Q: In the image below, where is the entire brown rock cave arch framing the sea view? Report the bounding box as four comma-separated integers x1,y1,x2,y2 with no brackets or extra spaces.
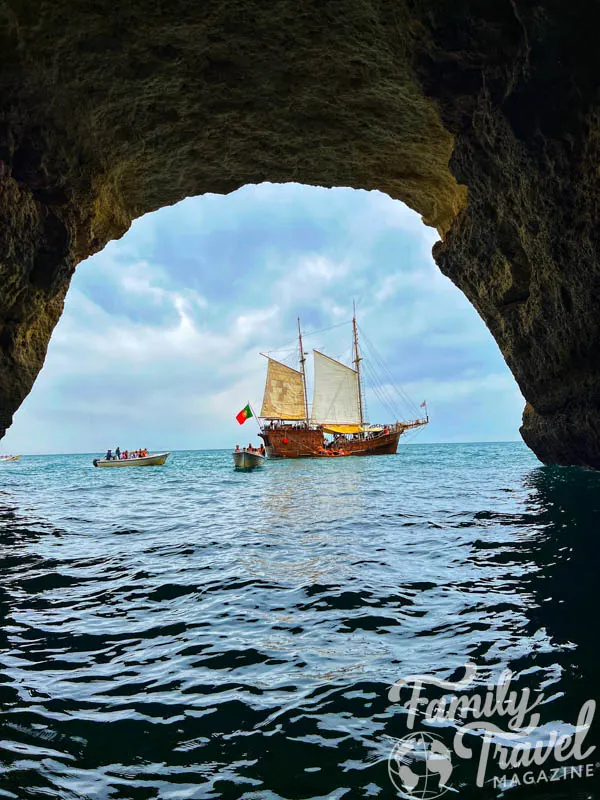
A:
0,0,600,466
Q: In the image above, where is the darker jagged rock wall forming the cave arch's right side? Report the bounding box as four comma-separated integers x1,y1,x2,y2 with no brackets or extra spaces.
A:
416,0,600,468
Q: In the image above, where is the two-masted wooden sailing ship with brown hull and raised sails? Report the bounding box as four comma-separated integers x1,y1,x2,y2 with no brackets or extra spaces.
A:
258,311,429,458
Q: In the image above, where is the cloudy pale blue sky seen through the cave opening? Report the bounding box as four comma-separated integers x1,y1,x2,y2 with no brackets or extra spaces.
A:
0,183,524,454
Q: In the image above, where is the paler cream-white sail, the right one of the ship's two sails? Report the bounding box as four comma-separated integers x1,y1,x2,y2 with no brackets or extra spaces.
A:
312,350,361,425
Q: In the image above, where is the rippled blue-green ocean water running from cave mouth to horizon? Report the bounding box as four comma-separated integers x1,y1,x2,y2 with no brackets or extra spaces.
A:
0,444,600,800
